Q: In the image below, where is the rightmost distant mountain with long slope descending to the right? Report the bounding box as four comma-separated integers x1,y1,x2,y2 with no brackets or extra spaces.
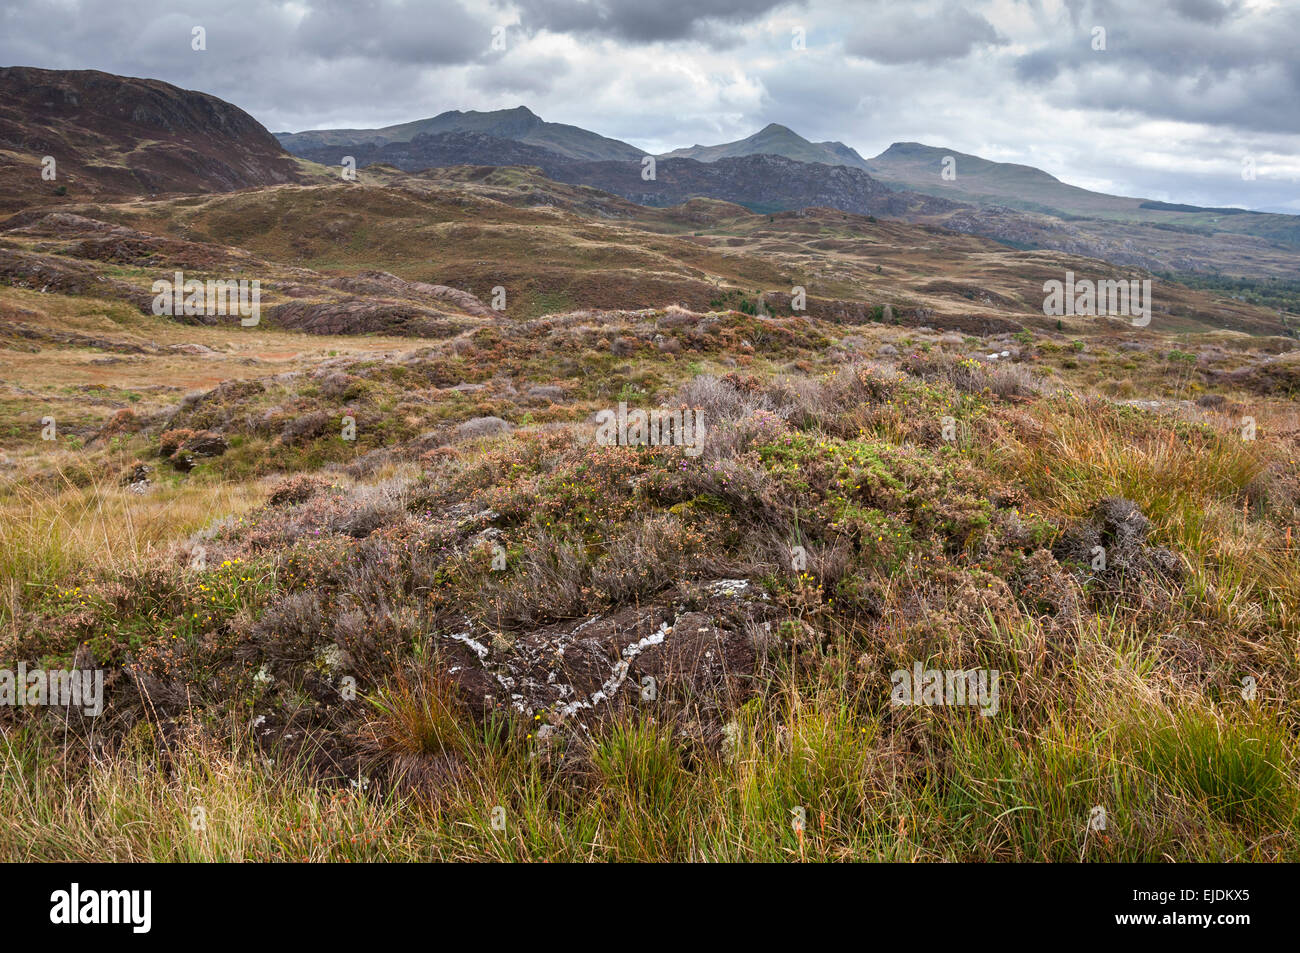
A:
866,142,1300,246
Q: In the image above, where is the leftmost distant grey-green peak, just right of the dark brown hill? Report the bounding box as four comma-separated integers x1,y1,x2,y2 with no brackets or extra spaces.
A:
276,105,645,165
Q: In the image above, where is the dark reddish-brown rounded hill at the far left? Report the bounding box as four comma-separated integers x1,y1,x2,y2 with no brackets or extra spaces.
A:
0,66,300,209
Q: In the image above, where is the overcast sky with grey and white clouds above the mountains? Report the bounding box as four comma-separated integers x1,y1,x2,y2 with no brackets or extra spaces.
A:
0,0,1300,212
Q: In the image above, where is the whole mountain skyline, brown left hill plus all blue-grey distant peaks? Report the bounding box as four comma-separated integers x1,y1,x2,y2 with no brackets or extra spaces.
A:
0,68,1300,281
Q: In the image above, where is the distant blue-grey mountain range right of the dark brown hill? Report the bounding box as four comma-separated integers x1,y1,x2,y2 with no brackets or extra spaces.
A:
278,107,1300,263
